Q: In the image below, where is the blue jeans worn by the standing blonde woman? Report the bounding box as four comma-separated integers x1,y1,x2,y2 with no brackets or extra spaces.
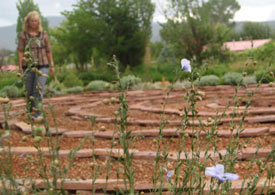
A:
25,67,49,116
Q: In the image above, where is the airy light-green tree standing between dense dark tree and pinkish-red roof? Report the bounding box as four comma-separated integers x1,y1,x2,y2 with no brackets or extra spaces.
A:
161,0,240,63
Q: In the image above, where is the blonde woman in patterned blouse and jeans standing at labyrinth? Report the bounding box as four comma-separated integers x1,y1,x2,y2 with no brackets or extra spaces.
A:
17,11,54,119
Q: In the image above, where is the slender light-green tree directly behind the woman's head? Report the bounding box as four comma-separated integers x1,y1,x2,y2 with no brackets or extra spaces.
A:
16,0,49,42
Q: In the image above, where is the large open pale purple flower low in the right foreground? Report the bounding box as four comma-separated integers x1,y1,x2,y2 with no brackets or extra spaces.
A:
205,164,239,182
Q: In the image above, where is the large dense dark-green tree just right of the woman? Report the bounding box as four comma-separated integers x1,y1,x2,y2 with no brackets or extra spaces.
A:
52,0,154,67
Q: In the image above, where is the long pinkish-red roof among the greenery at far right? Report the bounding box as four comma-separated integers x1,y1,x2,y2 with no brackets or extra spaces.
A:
224,39,271,51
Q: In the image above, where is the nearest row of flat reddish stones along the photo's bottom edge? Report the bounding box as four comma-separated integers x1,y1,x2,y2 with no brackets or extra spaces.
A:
6,178,275,195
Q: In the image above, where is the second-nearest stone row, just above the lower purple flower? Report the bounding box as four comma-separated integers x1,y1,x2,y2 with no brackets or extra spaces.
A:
0,147,273,161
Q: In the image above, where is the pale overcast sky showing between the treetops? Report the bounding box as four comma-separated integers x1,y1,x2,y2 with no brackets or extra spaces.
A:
0,0,275,26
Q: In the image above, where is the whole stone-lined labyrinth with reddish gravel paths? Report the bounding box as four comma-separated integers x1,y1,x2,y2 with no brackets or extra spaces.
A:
0,85,275,194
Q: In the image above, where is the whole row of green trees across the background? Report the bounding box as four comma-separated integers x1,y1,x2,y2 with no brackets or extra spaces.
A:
17,0,274,69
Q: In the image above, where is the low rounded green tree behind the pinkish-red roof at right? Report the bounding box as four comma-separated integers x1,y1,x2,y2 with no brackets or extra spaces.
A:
240,22,273,39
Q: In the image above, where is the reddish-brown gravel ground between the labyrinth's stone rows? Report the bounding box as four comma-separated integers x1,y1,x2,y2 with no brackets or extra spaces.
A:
0,85,275,186
